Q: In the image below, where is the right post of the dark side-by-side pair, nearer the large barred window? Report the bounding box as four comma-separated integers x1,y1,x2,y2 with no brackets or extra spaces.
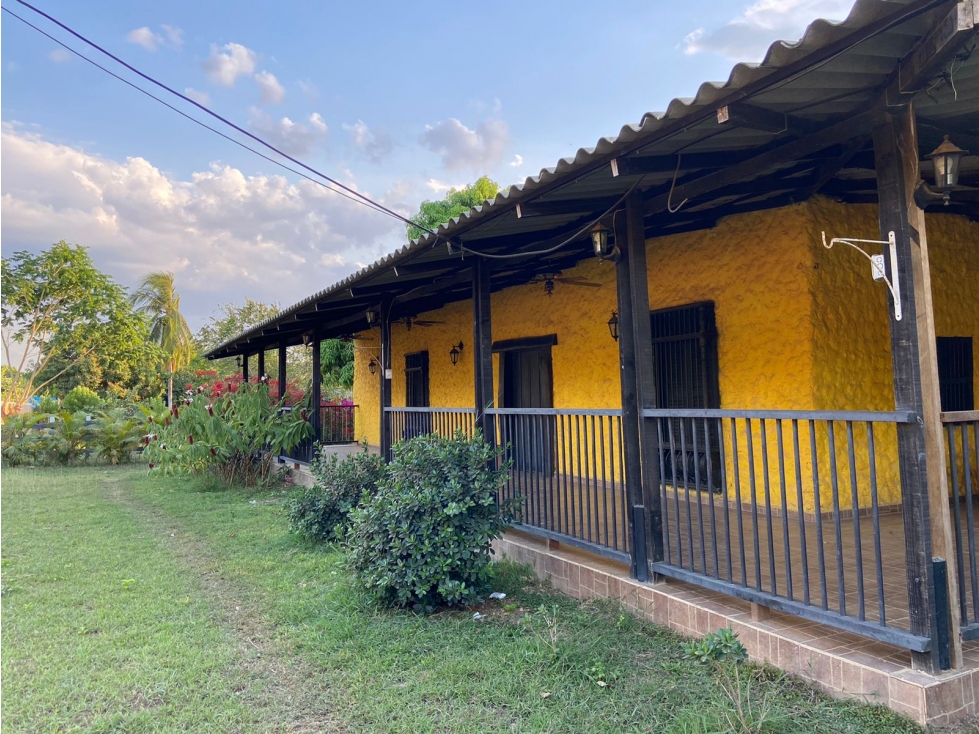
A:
620,191,663,576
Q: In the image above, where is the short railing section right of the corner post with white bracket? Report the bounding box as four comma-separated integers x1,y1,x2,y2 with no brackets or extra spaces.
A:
942,410,979,640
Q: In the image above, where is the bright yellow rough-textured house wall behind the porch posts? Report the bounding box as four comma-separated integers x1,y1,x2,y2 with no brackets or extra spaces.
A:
354,197,979,511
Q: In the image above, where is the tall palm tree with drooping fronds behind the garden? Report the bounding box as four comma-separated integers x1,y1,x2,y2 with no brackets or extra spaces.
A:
129,271,194,406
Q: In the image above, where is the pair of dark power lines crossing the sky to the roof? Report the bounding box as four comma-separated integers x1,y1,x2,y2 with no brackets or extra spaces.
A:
3,0,447,241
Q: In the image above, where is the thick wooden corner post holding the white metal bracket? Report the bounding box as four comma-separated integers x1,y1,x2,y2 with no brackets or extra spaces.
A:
874,104,962,673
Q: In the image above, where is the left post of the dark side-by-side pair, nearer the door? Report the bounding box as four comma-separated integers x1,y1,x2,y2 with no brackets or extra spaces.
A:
614,216,649,581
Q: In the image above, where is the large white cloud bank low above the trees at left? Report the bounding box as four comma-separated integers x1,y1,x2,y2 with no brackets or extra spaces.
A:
0,124,403,323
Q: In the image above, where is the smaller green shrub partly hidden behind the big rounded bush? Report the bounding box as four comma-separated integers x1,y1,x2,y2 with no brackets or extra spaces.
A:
289,452,386,543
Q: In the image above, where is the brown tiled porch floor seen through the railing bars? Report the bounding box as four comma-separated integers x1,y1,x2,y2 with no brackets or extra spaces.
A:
508,472,979,630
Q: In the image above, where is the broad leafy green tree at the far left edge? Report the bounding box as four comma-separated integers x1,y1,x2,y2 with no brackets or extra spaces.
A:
0,240,145,419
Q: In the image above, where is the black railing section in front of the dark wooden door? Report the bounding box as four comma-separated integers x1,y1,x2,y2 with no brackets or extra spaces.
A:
486,408,631,562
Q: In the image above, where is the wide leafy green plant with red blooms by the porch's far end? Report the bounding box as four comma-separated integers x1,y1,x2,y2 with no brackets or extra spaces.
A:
143,381,312,485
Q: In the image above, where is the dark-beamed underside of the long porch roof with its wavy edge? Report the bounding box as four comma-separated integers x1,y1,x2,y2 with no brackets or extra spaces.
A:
206,0,979,359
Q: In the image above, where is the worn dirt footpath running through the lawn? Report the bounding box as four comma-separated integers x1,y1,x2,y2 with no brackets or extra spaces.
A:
106,478,346,734
